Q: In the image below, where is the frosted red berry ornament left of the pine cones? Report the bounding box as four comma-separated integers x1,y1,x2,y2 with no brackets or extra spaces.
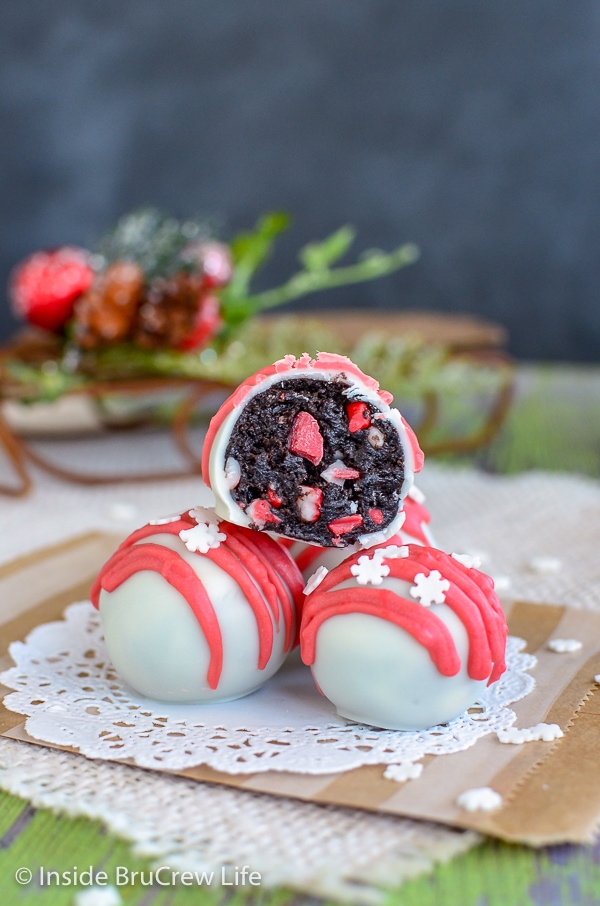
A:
9,246,94,331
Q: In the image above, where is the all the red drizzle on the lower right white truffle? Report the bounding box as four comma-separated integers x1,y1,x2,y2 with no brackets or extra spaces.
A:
300,544,507,685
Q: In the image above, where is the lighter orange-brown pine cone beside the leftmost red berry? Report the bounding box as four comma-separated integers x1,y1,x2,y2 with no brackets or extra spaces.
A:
74,261,144,349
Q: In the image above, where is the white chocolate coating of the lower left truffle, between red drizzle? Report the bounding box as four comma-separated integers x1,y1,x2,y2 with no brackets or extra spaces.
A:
99,534,293,702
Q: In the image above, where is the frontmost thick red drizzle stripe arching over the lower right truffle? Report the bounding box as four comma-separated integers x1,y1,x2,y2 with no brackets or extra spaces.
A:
302,588,460,676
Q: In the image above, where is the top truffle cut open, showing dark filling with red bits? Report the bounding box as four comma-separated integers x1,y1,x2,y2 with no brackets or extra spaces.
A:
202,353,423,548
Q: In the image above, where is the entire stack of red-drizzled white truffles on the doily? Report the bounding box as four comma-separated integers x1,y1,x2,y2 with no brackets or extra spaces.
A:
93,353,506,729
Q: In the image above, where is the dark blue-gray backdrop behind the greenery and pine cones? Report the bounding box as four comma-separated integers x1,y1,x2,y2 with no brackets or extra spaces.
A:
0,0,600,361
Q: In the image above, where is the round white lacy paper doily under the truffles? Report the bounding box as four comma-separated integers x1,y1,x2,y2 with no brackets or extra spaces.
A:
0,602,535,774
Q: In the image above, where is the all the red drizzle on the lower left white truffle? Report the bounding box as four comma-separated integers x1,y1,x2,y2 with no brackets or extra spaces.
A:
90,513,304,689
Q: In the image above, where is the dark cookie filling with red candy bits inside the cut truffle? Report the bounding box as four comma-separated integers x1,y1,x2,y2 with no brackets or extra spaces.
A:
225,378,404,547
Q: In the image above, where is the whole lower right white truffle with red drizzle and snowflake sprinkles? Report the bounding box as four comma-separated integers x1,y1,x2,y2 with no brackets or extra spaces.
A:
300,544,507,730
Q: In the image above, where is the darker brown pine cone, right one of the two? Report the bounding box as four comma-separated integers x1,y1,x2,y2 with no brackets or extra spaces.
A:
133,271,201,349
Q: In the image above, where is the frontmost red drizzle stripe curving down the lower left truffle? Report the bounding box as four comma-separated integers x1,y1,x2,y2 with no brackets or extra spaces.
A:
102,543,223,689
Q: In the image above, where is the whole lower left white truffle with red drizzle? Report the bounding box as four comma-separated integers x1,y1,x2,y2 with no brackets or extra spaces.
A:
92,507,303,702
